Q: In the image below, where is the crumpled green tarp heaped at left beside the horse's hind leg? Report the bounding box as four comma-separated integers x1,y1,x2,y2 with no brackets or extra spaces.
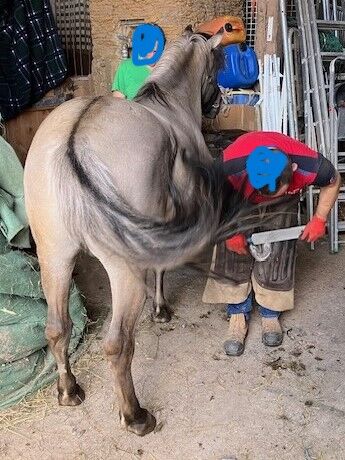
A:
0,136,87,410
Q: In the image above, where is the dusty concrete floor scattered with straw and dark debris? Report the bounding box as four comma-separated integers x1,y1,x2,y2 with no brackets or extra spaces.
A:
0,245,345,460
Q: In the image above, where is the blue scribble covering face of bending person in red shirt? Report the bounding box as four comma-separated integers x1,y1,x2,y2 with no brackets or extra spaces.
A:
246,147,288,193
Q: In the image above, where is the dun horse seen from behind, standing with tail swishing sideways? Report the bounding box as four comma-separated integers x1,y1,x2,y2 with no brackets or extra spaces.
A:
24,27,242,436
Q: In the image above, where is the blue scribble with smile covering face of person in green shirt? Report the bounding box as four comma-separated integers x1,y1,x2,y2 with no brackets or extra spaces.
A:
132,24,165,65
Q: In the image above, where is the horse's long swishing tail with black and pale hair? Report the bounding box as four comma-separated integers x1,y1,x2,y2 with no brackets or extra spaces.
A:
55,97,245,268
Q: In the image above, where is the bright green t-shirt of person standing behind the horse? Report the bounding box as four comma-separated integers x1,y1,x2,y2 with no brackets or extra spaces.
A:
111,59,151,100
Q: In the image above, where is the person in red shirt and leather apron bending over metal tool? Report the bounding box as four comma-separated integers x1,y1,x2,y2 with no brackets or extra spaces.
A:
203,132,340,356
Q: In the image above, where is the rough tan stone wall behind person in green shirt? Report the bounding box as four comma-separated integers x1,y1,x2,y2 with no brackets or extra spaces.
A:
90,0,243,94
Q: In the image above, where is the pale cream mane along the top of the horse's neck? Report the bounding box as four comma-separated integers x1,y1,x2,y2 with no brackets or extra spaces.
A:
134,34,224,105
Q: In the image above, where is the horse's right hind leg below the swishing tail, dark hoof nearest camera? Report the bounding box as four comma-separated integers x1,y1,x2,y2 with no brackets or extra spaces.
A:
97,253,156,436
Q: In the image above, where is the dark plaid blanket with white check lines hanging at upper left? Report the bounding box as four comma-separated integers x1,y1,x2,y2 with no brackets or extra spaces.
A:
0,0,67,120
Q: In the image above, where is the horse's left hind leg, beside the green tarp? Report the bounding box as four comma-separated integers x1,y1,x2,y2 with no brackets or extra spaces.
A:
36,239,85,406
